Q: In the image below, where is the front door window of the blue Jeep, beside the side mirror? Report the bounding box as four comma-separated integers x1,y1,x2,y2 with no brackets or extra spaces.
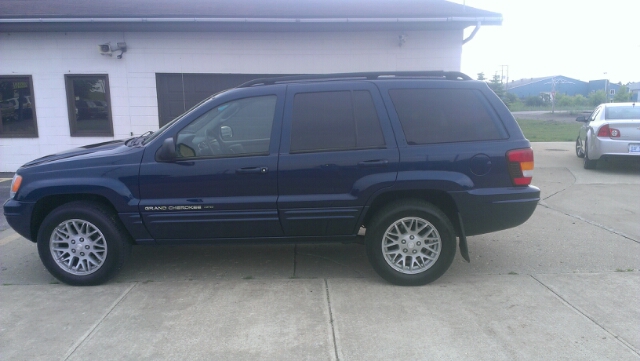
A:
176,95,278,158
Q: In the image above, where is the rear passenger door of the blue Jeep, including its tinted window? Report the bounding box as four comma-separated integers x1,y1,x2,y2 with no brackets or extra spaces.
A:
278,82,399,236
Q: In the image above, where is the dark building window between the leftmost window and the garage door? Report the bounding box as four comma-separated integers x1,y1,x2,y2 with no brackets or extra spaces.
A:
65,75,113,137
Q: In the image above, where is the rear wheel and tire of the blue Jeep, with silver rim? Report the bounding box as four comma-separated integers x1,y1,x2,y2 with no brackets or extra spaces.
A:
365,200,456,286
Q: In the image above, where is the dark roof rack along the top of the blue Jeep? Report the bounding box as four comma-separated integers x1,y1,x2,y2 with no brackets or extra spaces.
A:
238,70,472,88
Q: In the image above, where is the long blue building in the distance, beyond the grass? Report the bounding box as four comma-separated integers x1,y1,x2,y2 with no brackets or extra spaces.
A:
505,75,620,101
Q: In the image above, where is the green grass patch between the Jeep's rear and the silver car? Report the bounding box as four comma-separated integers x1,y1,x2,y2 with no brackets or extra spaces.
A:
518,119,582,142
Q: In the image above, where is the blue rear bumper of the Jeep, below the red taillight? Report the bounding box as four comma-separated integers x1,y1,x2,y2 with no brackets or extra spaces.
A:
451,186,540,236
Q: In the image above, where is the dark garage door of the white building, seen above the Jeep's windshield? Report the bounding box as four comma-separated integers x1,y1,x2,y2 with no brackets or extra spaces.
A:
156,73,280,126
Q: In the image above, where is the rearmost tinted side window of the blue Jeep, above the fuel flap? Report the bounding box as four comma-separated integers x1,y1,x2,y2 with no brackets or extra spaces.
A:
389,89,506,145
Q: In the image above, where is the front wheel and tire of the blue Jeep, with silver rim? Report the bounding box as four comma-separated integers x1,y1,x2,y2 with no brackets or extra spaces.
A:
38,201,131,286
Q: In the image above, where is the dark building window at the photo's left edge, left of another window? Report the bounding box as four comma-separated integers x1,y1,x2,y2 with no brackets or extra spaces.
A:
0,76,38,138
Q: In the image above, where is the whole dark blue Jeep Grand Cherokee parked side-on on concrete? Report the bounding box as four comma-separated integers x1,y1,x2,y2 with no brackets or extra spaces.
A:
4,72,540,285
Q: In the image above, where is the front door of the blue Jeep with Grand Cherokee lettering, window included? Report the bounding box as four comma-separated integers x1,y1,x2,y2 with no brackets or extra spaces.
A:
140,87,284,242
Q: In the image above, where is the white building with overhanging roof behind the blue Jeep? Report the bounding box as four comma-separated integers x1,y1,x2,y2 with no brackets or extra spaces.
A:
0,0,502,172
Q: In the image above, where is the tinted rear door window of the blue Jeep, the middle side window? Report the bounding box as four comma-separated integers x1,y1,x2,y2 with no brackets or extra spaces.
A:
291,91,384,153
